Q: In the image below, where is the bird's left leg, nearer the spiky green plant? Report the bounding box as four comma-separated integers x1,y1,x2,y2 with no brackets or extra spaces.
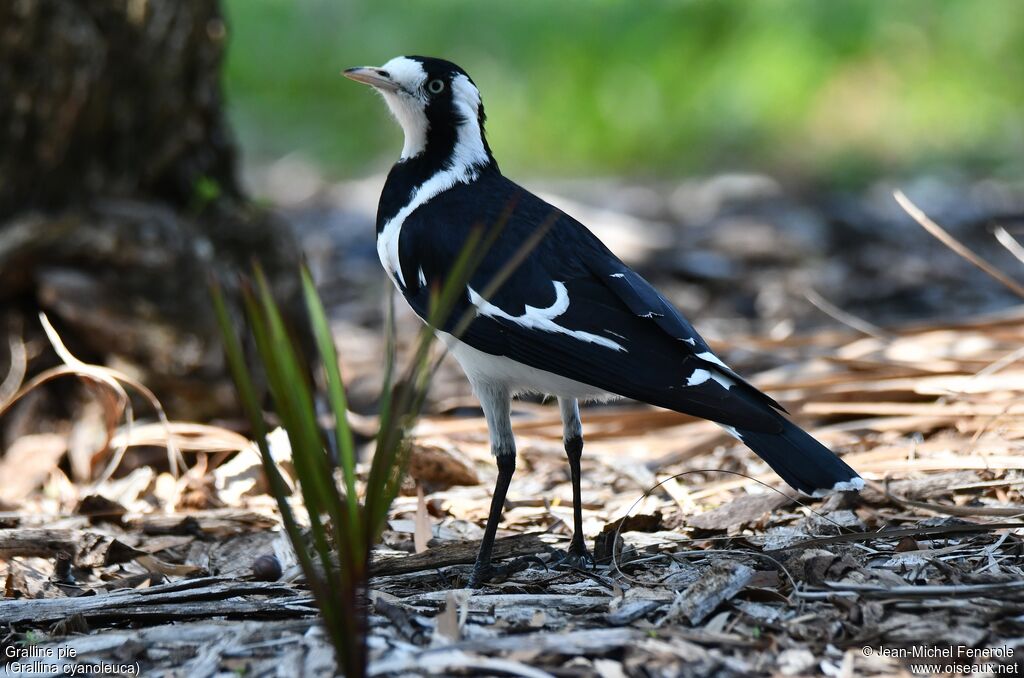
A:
469,386,544,588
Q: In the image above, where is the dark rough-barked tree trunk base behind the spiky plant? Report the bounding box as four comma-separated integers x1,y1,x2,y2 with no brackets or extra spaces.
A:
0,0,298,416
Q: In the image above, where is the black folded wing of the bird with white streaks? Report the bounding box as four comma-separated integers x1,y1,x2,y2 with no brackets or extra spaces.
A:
399,173,782,432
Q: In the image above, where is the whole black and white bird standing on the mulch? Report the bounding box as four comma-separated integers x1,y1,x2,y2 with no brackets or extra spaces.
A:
344,56,863,586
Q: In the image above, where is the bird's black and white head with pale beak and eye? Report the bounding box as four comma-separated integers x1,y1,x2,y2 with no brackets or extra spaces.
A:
343,56,494,167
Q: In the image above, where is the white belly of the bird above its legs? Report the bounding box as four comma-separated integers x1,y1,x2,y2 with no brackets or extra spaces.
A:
437,332,615,400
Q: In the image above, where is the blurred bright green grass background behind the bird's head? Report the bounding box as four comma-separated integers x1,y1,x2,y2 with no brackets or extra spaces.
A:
226,0,1024,183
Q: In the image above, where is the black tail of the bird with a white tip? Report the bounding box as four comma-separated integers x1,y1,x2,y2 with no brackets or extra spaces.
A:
736,417,864,497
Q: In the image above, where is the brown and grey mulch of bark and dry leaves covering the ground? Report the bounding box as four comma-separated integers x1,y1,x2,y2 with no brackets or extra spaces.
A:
0,308,1024,676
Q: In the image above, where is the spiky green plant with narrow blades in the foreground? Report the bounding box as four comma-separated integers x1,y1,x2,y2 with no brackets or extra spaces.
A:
212,242,480,678
